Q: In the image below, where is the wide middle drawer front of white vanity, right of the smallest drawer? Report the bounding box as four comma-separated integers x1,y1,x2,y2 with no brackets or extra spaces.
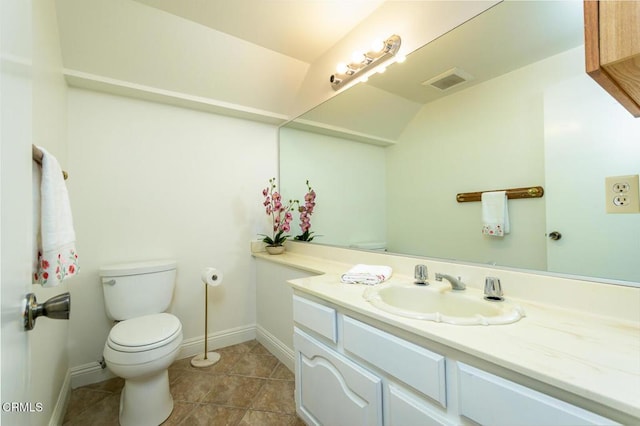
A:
343,316,447,407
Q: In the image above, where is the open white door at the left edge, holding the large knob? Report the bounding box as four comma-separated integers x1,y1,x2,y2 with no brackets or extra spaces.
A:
0,0,37,426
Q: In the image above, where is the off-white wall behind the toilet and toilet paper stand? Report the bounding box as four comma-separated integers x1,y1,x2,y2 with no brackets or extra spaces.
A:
69,89,277,366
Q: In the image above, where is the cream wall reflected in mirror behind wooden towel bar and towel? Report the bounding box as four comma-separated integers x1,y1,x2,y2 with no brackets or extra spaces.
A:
387,49,583,270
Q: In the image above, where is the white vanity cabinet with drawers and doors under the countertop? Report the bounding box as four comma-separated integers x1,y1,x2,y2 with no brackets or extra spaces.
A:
293,292,618,426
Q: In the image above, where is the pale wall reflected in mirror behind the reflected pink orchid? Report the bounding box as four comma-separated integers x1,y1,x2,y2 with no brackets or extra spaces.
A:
280,128,386,246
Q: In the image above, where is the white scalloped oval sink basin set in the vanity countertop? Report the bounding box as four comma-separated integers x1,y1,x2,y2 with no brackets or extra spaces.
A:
363,284,524,325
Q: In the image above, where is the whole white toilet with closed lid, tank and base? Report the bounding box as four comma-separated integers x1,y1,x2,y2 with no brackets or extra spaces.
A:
100,261,182,426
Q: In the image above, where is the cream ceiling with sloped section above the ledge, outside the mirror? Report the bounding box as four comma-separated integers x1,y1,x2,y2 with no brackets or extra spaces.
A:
56,0,382,123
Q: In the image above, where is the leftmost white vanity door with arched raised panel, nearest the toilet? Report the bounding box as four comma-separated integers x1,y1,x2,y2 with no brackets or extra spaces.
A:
293,328,382,426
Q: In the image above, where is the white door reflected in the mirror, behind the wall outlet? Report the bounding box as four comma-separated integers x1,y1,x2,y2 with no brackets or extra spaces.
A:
544,74,640,282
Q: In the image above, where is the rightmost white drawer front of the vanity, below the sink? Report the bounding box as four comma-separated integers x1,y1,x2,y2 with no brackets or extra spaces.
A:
458,363,619,426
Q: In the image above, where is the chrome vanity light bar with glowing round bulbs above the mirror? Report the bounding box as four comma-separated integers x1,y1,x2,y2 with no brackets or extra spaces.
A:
329,34,404,90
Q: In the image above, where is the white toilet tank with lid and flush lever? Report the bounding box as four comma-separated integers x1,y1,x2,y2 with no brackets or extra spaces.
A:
99,260,176,321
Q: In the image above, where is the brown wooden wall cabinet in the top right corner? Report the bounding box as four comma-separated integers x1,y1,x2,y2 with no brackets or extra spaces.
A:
584,0,640,117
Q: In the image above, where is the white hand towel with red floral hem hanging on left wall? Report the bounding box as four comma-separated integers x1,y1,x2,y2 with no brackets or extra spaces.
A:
33,147,79,287
